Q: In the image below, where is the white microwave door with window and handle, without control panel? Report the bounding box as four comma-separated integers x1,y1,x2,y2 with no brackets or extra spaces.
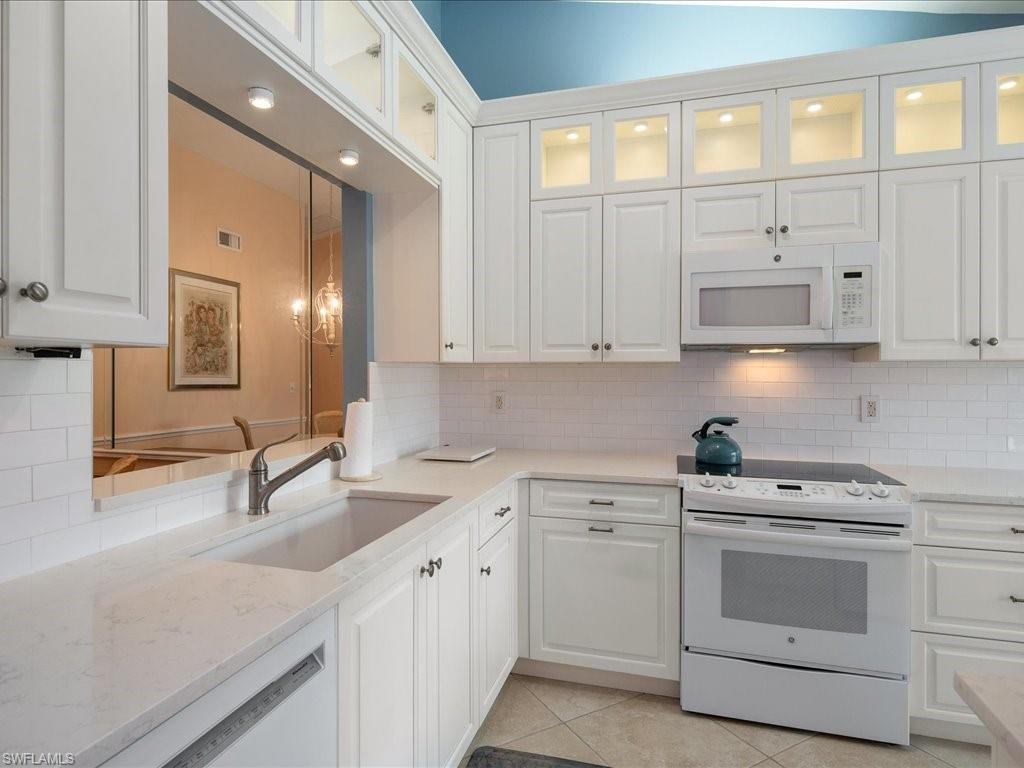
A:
681,246,834,344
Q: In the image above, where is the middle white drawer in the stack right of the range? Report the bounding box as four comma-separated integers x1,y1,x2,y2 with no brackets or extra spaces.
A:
912,547,1024,641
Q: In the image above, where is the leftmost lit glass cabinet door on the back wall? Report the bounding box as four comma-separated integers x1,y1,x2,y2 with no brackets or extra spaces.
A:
530,112,604,200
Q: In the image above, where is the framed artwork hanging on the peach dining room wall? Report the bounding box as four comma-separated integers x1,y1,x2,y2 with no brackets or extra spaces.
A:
167,269,242,390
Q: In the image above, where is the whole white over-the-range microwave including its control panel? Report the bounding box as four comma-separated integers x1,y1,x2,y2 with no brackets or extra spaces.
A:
681,243,879,346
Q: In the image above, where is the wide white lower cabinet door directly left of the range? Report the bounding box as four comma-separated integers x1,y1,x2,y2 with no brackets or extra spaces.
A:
529,517,680,680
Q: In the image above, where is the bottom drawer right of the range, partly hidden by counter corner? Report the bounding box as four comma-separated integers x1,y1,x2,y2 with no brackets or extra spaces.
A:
910,632,1024,725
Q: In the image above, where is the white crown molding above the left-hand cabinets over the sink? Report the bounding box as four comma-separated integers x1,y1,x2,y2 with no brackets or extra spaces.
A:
372,0,480,125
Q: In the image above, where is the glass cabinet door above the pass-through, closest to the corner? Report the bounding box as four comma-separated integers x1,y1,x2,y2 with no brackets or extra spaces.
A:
394,38,440,170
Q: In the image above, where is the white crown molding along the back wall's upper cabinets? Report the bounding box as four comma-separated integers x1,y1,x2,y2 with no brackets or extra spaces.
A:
475,27,1024,125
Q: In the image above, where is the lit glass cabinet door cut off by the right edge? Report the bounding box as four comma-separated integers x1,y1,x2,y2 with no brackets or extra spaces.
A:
981,58,1024,160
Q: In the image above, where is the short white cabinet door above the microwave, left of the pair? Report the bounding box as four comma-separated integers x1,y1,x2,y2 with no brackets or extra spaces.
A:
682,181,775,253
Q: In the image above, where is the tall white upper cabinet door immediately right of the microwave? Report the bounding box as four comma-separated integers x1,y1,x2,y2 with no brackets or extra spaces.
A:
880,164,981,360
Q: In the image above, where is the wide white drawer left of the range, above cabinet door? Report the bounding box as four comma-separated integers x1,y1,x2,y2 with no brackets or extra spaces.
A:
529,480,679,526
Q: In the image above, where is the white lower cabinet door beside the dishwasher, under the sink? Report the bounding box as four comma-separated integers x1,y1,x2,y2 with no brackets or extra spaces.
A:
338,547,429,766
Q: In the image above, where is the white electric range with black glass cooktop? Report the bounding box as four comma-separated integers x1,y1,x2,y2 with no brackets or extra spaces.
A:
679,457,911,744
